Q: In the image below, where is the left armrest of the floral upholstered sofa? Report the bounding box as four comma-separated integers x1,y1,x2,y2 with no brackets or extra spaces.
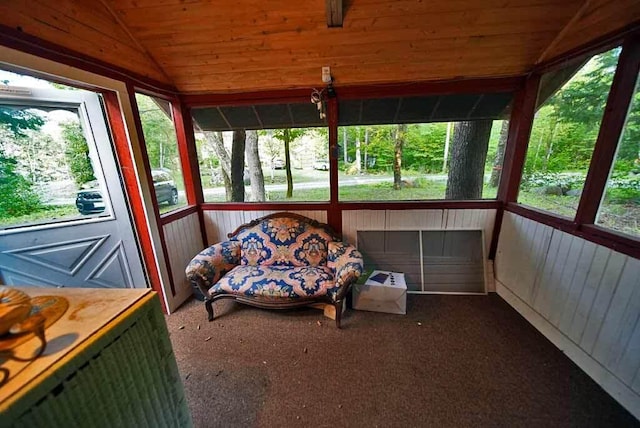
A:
185,241,240,298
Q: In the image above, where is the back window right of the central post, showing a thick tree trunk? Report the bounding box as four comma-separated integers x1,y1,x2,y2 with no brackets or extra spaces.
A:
338,93,513,201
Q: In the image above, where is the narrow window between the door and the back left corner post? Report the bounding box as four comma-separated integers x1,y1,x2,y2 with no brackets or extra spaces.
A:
136,94,187,214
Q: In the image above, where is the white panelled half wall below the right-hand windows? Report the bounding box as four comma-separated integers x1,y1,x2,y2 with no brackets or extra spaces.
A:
495,212,640,418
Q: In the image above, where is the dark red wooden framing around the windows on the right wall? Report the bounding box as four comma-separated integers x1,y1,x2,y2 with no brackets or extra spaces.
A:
502,32,640,258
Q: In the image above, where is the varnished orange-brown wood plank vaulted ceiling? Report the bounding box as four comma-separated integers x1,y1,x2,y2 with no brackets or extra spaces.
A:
0,0,640,93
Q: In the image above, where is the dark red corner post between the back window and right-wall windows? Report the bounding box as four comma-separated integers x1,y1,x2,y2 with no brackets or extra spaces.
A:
499,74,540,202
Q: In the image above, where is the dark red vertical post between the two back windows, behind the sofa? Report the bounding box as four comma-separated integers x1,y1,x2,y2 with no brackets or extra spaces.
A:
326,96,342,236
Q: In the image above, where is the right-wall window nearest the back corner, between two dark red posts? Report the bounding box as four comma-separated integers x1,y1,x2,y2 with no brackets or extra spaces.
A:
518,48,620,218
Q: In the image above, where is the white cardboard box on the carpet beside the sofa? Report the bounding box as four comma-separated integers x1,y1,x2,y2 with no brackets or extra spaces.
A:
352,270,407,315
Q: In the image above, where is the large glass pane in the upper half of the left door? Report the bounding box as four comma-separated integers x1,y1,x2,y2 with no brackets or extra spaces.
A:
0,71,111,229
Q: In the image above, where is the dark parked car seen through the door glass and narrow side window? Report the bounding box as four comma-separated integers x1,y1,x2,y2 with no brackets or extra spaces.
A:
76,169,178,215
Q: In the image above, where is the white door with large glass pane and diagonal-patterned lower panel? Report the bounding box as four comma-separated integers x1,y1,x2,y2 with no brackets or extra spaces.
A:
0,89,147,288
